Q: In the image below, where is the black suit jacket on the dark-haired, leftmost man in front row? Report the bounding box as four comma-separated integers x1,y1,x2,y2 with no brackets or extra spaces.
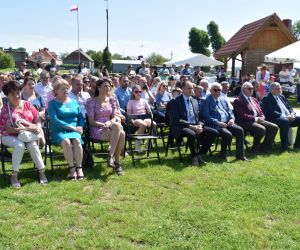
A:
171,95,202,138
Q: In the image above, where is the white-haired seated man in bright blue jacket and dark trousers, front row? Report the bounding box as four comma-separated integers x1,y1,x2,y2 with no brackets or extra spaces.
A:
202,82,248,161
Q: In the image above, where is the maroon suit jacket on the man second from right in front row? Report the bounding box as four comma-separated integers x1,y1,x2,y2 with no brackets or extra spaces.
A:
233,95,264,129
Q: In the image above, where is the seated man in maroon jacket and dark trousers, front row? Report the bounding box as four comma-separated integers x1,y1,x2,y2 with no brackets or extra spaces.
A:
233,82,278,153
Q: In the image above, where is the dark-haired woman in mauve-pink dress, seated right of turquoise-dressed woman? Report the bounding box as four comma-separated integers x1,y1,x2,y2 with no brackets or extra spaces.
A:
87,80,125,175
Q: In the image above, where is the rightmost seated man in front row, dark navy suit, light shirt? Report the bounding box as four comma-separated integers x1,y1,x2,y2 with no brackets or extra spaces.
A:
262,82,300,151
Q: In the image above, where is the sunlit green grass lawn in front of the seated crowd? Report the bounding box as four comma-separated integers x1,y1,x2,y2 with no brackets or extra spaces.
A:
0,97,300,249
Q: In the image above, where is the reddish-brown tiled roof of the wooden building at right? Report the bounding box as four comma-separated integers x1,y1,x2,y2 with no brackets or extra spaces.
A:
214,13,296,58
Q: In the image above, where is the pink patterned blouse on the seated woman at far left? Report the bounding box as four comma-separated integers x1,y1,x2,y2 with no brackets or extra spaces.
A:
0,101,39,136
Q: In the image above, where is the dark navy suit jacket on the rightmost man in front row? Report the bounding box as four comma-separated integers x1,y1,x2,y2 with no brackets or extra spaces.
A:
261,93,294,122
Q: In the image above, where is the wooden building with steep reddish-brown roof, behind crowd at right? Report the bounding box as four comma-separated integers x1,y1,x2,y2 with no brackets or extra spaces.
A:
214,13,296,77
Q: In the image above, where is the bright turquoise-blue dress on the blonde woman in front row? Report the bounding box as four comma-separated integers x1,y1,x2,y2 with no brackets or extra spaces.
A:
48,99,84,144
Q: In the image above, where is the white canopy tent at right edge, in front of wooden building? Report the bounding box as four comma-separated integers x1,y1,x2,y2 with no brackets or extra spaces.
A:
265,41,300,64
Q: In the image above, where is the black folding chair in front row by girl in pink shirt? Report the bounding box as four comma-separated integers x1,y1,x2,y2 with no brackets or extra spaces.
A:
125,113,160,166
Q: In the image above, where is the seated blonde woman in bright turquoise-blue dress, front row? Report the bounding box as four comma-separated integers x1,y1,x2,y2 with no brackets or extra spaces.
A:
48,79,84,180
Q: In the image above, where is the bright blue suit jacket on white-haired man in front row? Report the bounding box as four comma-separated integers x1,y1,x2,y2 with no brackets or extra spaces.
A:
201,95,235,129
